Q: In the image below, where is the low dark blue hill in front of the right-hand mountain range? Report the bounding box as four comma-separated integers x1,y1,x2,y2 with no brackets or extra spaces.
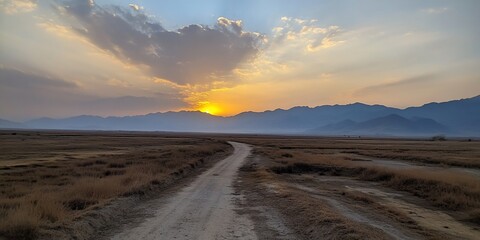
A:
307,114,451,136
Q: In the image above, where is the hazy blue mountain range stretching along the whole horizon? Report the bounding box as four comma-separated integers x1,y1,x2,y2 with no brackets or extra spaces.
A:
0,96,480,136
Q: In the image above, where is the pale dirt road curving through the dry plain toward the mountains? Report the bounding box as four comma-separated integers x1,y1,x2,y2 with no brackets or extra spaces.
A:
112,142,257,240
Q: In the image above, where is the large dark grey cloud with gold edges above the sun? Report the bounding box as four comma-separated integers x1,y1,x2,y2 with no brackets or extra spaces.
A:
57,0,263,84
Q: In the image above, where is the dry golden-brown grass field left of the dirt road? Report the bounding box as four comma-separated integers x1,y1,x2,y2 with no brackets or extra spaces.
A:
0,132,231,239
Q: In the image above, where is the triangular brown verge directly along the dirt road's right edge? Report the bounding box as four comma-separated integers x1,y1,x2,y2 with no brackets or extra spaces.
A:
236,157,392,239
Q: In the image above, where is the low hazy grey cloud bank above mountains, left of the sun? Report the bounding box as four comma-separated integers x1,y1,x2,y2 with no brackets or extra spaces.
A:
0,67,187,120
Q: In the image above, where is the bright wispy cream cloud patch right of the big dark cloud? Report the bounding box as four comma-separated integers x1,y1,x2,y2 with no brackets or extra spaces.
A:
221,17,346,87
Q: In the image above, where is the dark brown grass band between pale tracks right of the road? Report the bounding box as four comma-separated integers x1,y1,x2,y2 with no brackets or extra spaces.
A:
264,152,480,211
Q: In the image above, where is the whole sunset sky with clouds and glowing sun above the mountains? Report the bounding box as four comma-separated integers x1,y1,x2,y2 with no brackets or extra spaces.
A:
0,0,480,121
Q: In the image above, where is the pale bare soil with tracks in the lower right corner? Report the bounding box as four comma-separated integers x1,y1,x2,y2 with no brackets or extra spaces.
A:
291,175,480,239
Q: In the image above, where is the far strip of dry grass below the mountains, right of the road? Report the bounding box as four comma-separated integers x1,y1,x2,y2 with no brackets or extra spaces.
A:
237,136,480,168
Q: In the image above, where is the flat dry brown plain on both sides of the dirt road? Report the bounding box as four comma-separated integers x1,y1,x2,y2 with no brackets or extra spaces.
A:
0,131,480,239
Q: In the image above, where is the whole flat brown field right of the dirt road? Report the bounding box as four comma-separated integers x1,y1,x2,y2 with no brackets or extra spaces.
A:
231,136,480,239
